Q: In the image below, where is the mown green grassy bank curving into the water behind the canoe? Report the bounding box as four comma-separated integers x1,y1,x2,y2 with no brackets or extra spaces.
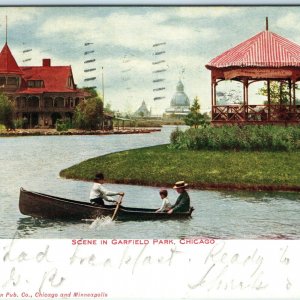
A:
60,145,300,191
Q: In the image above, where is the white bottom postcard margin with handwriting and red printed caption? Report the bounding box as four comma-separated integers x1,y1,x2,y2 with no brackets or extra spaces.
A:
0,238,300,299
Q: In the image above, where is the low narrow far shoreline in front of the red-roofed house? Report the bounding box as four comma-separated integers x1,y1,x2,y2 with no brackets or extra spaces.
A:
0,127,161,137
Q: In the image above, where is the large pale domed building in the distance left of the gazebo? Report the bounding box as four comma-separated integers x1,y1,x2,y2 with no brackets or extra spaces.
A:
165,80,191,117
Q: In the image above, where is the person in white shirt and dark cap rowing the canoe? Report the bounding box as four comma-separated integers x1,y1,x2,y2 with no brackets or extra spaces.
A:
90,173,124,205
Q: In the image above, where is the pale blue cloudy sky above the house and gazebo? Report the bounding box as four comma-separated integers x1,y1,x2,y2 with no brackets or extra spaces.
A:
0,6,300,115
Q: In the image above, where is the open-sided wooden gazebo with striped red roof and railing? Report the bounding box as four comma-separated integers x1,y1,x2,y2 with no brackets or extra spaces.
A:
206,19,300,124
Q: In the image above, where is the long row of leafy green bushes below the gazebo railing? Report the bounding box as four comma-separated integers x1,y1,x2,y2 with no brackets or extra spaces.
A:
170,125,300,151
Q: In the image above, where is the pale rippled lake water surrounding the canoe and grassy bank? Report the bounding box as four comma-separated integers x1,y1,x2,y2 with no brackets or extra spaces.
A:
0,126,300,239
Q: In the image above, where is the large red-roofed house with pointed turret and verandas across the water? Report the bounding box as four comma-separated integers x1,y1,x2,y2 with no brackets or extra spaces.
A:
0,43,84,128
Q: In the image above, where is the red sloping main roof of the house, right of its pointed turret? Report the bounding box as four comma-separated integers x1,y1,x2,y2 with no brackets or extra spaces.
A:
19,66,77,94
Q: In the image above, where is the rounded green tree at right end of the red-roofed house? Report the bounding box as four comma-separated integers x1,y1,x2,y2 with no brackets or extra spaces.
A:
74,93,103,130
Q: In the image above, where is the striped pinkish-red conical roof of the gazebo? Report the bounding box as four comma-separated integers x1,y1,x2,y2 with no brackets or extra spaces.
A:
206,30,300,69
